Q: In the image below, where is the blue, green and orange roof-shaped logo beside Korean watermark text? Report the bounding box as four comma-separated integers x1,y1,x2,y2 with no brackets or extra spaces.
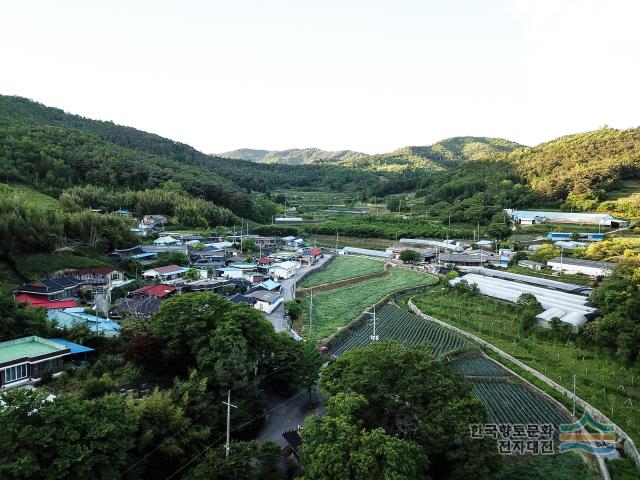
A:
560,412,616,456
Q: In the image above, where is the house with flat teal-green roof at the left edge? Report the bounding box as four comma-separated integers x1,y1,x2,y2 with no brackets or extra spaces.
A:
0,336,71,388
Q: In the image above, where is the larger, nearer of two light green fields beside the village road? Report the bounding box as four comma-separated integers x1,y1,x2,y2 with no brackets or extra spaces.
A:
302,267,437,341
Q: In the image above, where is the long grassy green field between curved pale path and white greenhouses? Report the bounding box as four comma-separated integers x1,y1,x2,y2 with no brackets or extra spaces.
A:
413,287,640,443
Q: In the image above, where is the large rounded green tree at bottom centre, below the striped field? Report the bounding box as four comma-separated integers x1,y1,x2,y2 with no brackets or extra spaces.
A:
320,342,498,479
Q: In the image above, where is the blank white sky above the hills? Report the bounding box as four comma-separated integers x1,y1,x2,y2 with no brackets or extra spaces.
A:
0,0,640,153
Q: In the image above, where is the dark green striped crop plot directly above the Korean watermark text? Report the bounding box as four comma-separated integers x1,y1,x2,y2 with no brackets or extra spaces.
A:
471,380,571,428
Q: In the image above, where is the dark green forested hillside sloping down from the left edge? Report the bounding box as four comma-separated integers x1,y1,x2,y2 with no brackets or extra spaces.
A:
0,95,404,220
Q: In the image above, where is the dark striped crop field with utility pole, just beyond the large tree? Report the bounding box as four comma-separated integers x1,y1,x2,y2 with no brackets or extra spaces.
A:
330,305,466,357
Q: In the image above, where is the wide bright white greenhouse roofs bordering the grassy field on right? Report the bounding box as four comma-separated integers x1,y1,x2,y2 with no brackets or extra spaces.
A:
449,273,597,329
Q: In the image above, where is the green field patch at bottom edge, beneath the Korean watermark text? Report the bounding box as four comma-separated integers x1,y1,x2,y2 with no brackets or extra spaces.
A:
491,452,600,480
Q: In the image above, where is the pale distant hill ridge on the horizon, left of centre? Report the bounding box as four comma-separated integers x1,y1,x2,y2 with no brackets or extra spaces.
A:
220,148,366,165
